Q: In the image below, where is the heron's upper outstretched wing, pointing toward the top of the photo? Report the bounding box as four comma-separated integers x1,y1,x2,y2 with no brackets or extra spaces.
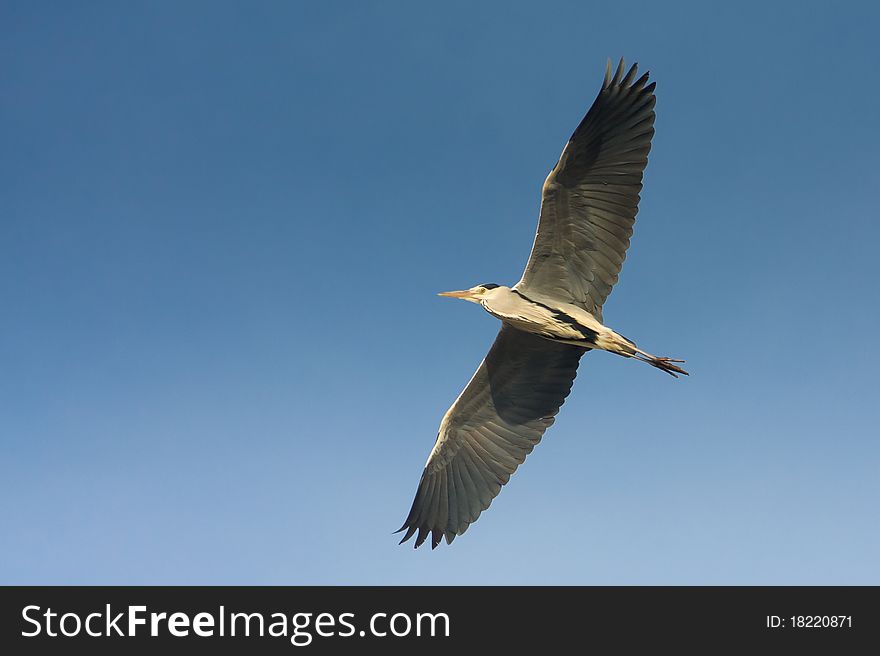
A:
516,59,655,321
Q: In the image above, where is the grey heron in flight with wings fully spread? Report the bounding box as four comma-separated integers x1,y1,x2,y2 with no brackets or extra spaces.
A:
396,59,688,549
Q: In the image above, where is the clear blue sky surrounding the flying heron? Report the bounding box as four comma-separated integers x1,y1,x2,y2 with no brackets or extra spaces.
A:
0,1,880,584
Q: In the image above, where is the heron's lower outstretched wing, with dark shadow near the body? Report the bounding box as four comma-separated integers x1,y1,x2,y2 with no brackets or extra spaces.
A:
400,325,586,548
